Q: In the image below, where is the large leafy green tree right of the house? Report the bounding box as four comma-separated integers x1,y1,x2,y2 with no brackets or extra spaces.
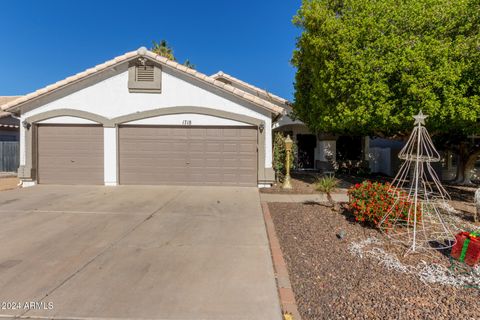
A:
293,0,480,182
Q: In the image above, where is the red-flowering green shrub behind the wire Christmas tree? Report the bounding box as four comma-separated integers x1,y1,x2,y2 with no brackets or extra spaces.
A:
348,181,422,228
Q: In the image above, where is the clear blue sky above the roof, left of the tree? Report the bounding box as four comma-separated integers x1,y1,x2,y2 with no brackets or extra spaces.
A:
0,0,301,99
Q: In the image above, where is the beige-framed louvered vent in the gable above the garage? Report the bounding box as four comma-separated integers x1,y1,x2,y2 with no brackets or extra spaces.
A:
128,59,162,93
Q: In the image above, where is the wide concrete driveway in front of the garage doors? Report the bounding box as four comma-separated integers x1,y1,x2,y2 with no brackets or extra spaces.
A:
0,186,281,320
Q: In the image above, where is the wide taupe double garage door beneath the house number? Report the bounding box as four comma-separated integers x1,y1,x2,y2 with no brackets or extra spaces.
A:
119,126,257,186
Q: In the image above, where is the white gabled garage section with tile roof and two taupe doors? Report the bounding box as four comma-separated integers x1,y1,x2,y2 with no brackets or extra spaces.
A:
3,48,287,186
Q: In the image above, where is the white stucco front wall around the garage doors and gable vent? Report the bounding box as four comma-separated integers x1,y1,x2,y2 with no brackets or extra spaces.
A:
20,67,272,184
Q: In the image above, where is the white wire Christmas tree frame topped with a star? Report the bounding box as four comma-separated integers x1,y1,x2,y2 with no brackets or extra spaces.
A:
379,111,454,253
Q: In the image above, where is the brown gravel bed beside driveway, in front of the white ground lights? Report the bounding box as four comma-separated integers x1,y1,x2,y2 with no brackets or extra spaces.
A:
269,203,480,320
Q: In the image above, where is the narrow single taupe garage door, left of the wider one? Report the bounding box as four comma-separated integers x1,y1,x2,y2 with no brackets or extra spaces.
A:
38,125,104,184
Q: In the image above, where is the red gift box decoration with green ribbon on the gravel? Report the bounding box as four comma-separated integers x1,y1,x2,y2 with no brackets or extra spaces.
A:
450,232,480,267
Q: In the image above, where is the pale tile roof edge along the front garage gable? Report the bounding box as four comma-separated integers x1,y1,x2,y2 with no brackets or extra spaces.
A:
1,47,284,114
